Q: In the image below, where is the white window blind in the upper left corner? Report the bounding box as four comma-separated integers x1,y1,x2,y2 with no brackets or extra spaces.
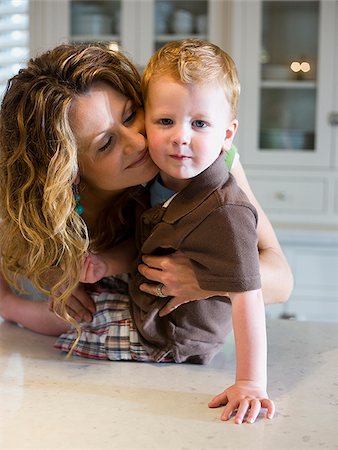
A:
0,0,29,98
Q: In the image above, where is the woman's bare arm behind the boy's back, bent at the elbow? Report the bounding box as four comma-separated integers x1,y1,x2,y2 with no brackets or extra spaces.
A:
231,161,293,304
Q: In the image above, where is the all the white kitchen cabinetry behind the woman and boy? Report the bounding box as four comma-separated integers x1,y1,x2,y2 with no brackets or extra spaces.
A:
30,0,338,320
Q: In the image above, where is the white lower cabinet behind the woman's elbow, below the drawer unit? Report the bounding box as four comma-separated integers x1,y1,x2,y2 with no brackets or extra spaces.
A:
267,229,338,322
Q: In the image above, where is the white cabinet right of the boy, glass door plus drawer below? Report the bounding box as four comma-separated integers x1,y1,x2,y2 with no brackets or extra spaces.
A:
232,0,338,230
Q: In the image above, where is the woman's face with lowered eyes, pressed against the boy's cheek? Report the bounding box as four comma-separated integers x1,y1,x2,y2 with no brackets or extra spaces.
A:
69,83,158,195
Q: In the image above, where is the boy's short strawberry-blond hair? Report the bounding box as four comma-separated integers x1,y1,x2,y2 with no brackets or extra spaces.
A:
141,39,240,119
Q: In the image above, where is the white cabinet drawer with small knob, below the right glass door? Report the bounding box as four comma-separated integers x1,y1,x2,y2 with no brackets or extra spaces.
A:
250,176,325,213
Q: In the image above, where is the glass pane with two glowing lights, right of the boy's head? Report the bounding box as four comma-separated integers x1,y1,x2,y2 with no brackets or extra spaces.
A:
259,1,319,152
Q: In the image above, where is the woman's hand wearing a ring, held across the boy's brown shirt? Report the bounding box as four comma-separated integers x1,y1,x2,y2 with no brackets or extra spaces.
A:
138,252,227,317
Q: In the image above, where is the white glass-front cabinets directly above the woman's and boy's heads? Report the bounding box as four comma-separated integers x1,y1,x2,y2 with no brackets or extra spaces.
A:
31,0,229,68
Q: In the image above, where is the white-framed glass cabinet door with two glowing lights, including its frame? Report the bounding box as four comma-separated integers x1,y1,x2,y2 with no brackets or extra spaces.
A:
234,0,338,167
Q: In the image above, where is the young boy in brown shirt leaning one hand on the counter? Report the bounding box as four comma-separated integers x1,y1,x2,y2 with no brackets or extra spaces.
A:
125,40,273,422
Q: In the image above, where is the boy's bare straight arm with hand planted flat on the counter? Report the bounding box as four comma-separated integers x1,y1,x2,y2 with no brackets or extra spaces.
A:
209,289,275,423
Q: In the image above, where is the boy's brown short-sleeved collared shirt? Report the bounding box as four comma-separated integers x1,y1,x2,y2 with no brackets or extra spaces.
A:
130,155,260,364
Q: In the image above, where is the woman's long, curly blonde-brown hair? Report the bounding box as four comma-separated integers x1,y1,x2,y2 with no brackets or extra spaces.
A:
0,44,141,321
